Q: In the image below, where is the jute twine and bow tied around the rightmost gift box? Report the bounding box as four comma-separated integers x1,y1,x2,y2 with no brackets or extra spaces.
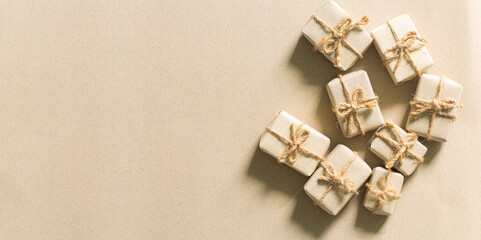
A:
409,75,464,140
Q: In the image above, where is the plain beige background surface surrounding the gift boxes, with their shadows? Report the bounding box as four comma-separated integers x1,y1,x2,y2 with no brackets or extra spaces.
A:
0,0,481,239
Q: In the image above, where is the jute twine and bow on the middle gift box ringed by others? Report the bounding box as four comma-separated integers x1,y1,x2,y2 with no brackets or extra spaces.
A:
332,75,378,135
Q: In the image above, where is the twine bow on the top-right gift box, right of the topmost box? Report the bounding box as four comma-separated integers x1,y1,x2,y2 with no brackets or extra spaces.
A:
384,22,428,76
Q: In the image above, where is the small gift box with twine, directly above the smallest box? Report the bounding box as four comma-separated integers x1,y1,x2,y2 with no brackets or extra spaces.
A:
369,121,428,176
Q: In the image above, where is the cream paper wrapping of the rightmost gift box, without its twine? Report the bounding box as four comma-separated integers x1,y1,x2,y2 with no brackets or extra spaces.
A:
406,74,463,142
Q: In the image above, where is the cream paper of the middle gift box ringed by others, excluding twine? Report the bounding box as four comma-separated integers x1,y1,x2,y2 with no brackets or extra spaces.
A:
326,70,384,138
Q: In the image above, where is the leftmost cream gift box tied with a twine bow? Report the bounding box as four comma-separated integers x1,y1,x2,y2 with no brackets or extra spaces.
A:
259,111,331,176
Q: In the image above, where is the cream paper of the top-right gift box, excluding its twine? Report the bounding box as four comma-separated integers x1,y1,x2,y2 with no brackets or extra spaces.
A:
371,14,433,84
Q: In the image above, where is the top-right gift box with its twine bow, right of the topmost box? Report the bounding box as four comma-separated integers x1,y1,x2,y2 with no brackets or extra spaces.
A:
371,14,433,84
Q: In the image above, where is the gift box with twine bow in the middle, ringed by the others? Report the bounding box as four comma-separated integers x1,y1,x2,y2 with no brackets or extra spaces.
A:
326,70,384,138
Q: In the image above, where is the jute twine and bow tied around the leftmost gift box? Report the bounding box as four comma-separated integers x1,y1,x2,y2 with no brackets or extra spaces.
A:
266,123,324,164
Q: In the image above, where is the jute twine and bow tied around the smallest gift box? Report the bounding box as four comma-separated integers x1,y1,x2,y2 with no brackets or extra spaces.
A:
366,168,401,214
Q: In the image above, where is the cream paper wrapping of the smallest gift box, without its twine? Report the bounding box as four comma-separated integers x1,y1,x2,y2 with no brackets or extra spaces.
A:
363,167,404,215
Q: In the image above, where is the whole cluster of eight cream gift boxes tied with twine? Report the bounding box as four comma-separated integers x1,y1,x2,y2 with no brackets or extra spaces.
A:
259,1,463,215
